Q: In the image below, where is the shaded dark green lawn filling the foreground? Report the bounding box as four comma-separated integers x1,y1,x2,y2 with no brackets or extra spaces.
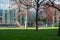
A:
0,29,60,40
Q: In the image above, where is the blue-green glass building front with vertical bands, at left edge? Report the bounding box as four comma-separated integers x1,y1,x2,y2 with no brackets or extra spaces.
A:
0,9,16,25
